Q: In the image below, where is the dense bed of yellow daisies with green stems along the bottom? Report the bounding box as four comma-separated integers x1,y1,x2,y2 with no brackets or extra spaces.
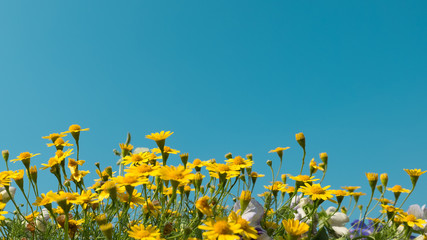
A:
0,125,427,240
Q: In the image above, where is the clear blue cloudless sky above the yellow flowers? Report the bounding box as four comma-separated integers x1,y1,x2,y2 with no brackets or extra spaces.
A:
0,1,427,216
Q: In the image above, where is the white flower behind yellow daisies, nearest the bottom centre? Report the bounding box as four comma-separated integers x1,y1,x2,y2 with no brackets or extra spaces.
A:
234,199,273,240
